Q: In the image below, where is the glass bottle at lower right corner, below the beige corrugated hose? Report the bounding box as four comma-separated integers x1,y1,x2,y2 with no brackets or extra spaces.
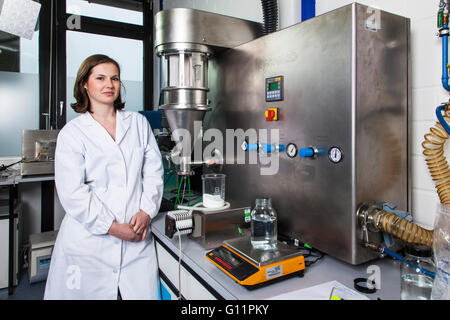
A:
400,244,435,300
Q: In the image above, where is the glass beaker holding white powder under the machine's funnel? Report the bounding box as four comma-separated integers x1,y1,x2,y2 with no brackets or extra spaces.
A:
202,173,225,208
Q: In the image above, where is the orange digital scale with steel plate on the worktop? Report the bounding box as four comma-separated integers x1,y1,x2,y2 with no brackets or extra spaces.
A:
206,236,305,290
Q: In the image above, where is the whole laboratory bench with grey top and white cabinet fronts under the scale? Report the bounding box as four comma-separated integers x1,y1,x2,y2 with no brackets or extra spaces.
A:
152,212,400,300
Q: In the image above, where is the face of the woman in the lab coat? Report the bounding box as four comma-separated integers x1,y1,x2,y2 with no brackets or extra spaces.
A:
84,63,120,106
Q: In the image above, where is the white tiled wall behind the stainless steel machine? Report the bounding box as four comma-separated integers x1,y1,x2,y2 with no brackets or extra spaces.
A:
156,0,449,229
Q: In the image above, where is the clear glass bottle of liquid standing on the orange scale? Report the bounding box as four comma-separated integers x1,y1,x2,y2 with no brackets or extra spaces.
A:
251,198,277,250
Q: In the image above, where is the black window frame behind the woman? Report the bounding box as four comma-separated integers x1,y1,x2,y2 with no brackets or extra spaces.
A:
39,0,154,232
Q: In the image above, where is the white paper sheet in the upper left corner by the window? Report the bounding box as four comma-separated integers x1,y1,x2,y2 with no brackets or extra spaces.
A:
0,0,41,40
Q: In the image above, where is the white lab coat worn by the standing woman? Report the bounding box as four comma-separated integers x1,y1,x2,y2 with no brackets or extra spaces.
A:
44,111,164,299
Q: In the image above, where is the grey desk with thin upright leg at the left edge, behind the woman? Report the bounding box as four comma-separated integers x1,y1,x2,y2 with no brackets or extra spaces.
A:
0,175,54,295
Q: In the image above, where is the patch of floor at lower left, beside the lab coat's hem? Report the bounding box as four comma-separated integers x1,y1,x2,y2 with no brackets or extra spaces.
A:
0,270,45,300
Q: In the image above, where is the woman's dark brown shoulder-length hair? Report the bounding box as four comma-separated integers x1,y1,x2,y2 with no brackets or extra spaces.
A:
71,54,125,113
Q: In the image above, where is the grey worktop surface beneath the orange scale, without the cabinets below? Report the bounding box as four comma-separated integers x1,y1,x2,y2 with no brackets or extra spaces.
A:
152,213,400,300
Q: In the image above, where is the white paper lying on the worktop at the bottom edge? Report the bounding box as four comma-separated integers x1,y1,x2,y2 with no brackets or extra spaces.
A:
269,281,369,300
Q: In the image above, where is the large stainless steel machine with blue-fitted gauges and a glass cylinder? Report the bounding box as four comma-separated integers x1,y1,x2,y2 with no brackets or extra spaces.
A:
155,3,410,264
